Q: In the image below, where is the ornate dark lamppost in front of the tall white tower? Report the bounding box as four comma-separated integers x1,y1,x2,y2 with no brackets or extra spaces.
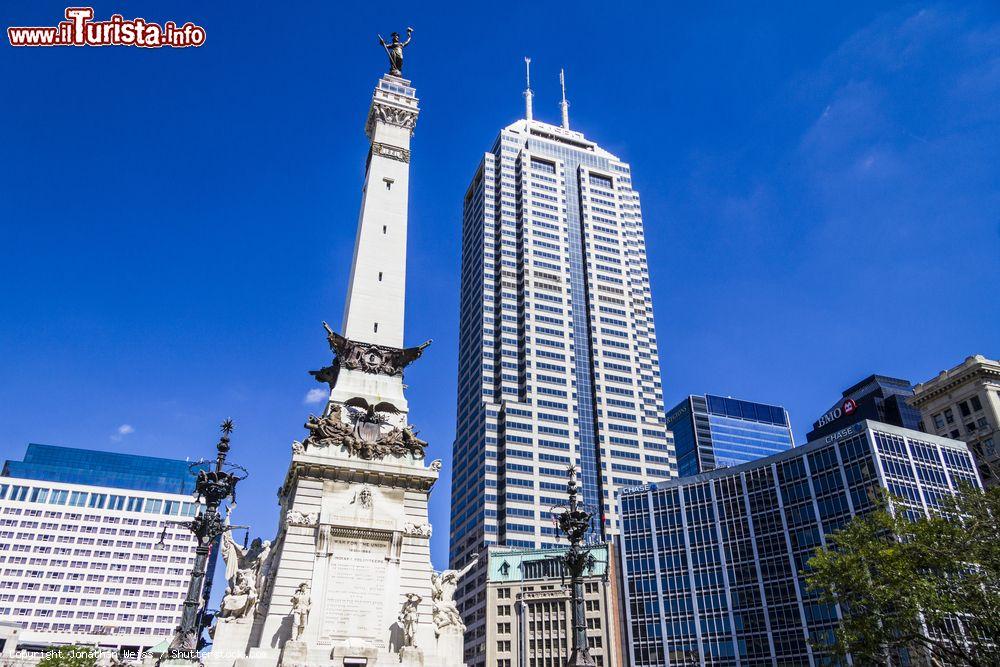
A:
553,465,597,667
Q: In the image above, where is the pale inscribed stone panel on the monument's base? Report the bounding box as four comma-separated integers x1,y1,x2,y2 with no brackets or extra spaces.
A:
322,536,390,648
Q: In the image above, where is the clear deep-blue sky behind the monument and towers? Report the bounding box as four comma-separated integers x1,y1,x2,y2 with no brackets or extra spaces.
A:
0,0,1000,588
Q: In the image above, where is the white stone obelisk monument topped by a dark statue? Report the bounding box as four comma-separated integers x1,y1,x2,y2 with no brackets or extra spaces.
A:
205,29,465,667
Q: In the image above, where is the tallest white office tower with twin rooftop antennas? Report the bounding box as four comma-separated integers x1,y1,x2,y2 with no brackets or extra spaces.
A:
449,70,676,666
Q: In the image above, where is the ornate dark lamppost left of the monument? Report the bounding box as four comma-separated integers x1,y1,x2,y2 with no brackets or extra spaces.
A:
160,419,247,663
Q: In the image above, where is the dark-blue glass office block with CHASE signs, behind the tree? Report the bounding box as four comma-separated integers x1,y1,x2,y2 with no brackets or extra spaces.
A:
620,421,979,667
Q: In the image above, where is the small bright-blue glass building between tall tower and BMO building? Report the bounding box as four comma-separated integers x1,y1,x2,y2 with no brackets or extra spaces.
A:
667,394,795,477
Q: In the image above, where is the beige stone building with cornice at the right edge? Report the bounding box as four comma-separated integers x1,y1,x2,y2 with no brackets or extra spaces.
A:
909,354,1000,486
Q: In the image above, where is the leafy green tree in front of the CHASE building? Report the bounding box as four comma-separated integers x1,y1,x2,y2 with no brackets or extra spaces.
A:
803,487,1000,667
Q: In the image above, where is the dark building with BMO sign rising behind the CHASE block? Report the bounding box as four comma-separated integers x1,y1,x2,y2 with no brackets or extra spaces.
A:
806,375,920,442
